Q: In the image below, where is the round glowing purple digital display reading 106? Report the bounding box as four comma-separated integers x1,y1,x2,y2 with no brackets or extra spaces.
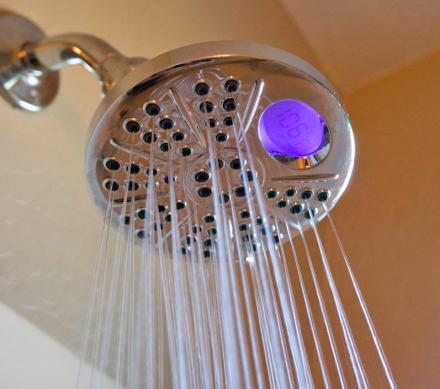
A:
258,99,325,158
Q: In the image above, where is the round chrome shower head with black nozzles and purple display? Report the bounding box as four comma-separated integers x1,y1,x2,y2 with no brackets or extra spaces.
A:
86,42,354,252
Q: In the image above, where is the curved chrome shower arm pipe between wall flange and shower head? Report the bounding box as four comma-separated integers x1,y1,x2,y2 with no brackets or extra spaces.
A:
24,34,146,94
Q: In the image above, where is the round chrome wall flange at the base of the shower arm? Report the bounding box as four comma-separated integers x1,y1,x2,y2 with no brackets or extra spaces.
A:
0,9,59,112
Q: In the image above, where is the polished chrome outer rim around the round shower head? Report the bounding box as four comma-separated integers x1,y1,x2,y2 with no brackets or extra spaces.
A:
85,41,354,233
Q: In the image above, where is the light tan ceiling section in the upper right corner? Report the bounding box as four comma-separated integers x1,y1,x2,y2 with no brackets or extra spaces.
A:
279,0,440,91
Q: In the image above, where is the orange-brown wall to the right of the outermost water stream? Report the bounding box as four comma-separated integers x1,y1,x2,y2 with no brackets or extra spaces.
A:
328,52,440,389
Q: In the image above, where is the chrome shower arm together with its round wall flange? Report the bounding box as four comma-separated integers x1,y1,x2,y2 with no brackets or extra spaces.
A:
0,9,146,112
